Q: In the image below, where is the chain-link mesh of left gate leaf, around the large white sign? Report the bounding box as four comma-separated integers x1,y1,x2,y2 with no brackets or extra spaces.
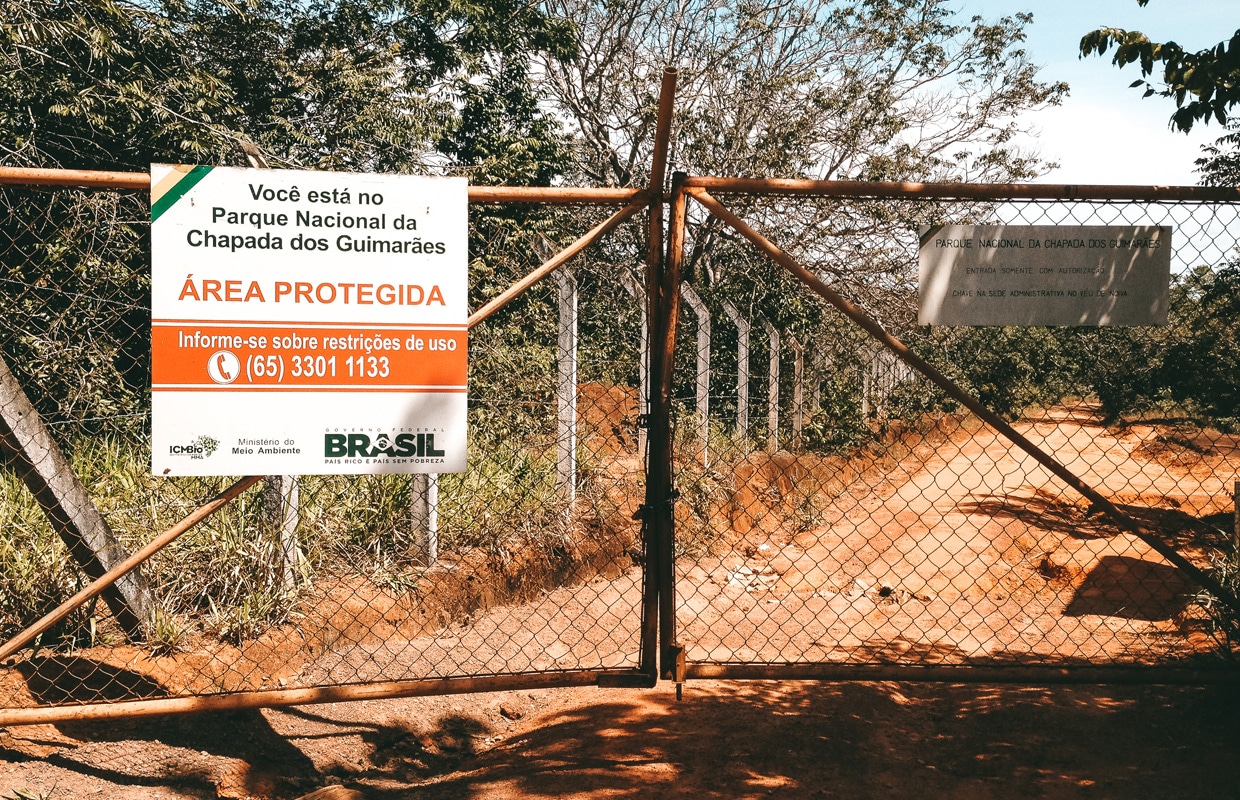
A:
0,186,645,708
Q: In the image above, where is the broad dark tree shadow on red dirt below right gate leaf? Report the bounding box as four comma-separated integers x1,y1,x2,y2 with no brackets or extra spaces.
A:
307,682,1240,800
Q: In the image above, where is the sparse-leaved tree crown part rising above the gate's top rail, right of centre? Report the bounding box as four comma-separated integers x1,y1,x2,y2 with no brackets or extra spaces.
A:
547,0,1066,185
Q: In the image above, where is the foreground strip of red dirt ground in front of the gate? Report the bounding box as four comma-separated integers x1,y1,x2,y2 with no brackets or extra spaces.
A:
0,681,1240,800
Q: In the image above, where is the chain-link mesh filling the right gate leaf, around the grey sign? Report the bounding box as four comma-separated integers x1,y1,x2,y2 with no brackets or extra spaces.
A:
665,181,1240,677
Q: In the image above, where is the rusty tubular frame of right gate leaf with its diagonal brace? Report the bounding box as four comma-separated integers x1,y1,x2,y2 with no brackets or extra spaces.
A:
651,172,1240,692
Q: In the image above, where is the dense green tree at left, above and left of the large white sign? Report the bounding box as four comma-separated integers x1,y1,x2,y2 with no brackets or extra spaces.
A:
0,0,574,439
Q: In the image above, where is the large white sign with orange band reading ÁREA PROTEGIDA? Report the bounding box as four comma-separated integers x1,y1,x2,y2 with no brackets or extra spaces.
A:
151,165,469,475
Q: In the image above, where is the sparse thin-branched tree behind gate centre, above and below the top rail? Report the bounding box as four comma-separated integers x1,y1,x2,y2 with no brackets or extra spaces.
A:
546,0,1066,339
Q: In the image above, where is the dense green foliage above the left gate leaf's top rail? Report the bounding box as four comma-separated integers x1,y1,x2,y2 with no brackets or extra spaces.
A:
0,0,574,174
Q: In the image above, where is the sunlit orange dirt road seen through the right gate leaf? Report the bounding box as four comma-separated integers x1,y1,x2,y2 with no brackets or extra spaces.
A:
680,409,1240,664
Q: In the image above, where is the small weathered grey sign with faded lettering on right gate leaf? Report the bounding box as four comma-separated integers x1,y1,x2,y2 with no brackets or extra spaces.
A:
918,224,1171,325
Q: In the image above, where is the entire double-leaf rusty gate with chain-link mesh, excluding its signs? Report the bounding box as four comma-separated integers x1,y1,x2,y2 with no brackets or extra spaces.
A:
0,73,1240,724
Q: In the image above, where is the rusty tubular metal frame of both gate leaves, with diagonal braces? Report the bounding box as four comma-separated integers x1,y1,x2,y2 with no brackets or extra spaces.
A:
7,69,1240,726
